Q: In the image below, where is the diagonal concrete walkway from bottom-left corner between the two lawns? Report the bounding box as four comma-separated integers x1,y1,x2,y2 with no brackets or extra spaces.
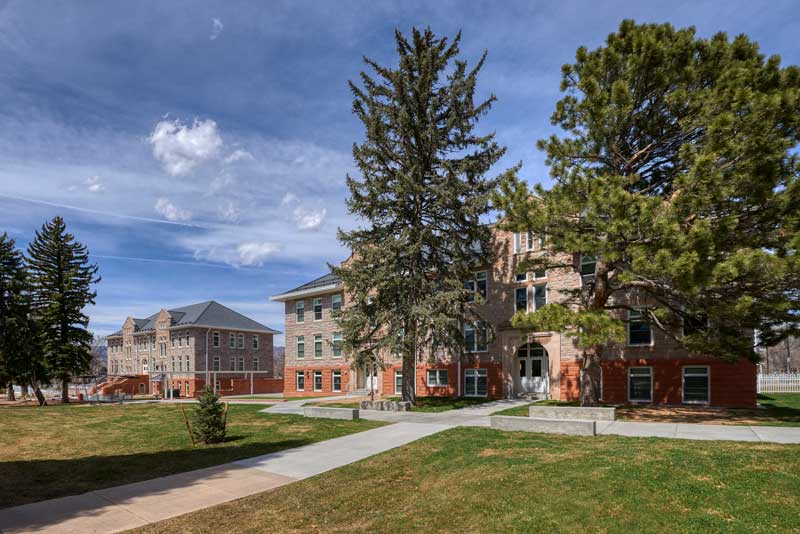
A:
0,423,451,534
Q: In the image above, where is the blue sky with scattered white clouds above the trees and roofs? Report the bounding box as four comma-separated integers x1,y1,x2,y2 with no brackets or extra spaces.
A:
0,0,800,344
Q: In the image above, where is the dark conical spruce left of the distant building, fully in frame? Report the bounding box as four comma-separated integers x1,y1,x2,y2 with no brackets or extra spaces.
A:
27,217,100,402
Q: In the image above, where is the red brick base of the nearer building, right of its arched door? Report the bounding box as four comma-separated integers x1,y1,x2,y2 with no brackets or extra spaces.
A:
561,358,756,408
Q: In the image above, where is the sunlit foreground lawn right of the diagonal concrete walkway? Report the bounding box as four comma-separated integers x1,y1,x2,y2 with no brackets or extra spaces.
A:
131,427,800,534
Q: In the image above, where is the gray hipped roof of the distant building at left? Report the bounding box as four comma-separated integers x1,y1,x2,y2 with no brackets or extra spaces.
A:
111,300,280,336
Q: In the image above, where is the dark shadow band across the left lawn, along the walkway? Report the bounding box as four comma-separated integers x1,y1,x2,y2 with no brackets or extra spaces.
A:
0,435,310,525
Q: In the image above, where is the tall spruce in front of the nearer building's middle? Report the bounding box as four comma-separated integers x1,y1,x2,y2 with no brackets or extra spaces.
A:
331,29,505,403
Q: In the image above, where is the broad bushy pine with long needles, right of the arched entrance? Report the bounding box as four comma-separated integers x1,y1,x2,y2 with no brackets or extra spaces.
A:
497,21,800,405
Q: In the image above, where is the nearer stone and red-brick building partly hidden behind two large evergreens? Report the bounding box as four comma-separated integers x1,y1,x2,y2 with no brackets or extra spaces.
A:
272,228,756,406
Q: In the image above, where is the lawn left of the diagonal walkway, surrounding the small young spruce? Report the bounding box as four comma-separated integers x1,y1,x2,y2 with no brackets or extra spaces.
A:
0,404,381,508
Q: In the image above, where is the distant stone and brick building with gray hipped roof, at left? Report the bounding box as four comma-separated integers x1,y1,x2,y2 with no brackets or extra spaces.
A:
107,301,282,397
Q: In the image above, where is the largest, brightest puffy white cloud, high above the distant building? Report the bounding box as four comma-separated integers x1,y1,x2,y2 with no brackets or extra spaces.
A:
147,119,222,176
